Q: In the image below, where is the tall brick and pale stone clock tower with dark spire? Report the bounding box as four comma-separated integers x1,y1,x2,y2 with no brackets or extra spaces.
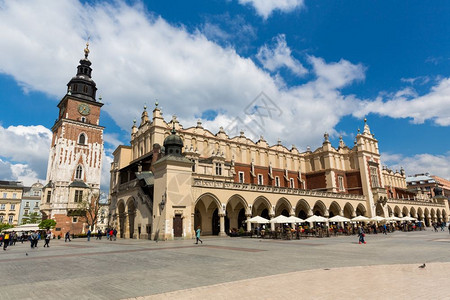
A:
41,43,104,235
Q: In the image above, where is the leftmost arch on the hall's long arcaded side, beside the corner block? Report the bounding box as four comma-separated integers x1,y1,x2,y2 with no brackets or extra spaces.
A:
194,193,223,235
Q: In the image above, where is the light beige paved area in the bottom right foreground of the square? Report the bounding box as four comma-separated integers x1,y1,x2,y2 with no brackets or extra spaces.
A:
137,263,450,300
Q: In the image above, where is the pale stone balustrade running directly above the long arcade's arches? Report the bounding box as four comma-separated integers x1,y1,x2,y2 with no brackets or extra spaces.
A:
194,178,366,201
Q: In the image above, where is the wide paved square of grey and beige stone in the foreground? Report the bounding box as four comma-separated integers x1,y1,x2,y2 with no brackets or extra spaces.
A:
0,230,450,299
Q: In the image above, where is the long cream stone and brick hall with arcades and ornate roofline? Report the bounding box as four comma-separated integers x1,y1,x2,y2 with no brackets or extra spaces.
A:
109,104,449,240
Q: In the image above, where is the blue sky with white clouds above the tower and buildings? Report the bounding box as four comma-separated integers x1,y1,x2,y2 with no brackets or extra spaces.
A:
0,0,450,189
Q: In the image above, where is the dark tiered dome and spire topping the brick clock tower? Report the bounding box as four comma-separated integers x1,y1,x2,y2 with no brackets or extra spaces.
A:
67,42,97,101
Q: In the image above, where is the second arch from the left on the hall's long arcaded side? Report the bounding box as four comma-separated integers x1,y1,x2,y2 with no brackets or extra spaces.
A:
225,194,249,233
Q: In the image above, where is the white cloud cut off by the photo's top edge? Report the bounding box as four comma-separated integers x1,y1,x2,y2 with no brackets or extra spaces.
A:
239,0,304,19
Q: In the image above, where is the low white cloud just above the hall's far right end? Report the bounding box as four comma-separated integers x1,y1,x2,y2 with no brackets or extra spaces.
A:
381,152,450,180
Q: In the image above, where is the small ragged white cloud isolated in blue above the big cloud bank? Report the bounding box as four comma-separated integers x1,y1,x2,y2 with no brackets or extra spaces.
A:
256,34,308,76
